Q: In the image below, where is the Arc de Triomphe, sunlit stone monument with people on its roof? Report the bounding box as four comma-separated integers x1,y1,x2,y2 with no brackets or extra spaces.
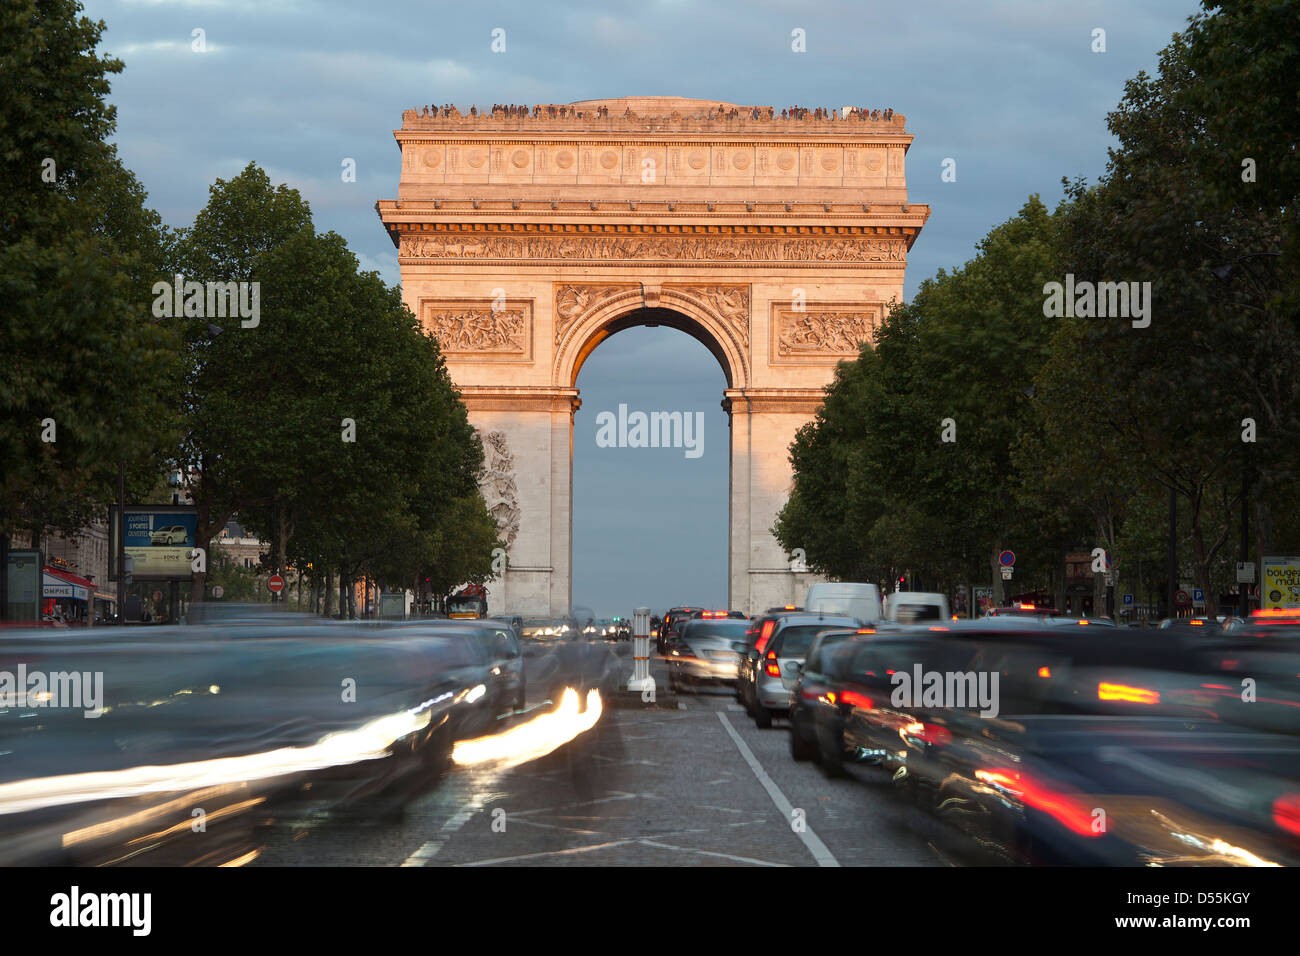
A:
376,96,930,615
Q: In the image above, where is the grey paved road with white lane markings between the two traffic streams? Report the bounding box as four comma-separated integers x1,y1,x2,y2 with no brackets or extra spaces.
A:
254,644,953,866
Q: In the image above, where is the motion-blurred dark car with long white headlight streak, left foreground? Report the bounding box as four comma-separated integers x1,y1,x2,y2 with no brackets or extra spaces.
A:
0,622,485,865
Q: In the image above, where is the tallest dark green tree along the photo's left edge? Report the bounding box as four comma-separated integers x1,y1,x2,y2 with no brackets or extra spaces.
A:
0,0,179,567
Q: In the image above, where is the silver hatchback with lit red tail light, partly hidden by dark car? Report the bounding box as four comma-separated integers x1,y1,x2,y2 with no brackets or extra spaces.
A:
736,614,858,730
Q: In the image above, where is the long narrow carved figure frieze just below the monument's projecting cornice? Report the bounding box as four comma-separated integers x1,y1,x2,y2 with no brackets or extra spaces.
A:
399,233,907,264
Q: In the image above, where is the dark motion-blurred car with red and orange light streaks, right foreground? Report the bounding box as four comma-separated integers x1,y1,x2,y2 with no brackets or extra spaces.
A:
835,622,1300,866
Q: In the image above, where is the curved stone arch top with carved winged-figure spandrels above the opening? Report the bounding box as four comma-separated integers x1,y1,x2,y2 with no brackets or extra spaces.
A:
553,285,750,389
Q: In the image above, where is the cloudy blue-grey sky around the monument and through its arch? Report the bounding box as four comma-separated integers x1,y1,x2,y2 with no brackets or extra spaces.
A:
86,0,1197,615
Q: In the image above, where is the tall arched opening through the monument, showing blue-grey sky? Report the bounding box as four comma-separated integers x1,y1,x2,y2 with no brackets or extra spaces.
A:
569,325,732,617
